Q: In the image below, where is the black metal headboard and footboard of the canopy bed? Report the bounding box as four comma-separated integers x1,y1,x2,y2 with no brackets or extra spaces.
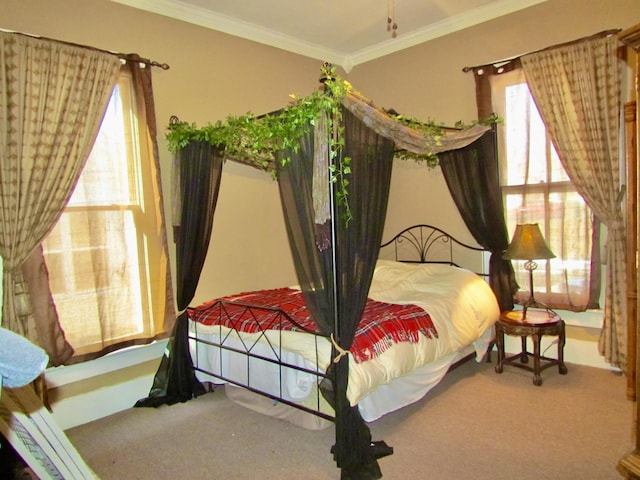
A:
189,224,486,421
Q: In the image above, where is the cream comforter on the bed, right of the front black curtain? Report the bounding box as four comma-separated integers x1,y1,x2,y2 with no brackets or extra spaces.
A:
347,260,500,405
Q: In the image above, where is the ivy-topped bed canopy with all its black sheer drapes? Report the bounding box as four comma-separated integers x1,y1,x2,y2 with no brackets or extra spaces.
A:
137,65,515,479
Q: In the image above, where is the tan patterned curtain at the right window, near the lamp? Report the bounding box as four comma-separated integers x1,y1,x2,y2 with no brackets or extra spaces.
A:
521,35,627,372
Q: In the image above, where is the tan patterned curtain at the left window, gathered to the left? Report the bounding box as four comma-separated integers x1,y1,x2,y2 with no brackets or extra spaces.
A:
0,32,120,362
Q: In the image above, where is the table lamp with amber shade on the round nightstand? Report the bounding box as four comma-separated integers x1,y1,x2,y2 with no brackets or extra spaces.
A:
502,223,555,319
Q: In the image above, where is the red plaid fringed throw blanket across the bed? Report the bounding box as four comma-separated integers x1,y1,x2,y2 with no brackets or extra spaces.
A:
189,288,438,363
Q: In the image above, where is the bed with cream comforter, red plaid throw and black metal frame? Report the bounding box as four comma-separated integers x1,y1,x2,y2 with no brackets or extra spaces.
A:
188,225,499,428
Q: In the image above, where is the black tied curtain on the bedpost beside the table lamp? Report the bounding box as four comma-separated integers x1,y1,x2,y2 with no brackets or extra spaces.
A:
438,129,518,311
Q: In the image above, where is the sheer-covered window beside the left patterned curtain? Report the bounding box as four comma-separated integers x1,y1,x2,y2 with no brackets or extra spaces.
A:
43,69,172,355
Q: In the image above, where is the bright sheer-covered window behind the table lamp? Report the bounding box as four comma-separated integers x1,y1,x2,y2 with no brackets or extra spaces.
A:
492,70,597,310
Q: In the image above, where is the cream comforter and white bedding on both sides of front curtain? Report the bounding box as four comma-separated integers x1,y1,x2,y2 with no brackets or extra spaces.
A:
191,260,499,421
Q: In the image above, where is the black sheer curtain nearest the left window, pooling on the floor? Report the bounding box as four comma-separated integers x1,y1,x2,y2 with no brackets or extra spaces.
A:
135,142,224,407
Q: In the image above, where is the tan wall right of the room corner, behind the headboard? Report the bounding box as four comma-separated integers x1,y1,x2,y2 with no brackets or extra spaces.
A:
349,0,640,248
